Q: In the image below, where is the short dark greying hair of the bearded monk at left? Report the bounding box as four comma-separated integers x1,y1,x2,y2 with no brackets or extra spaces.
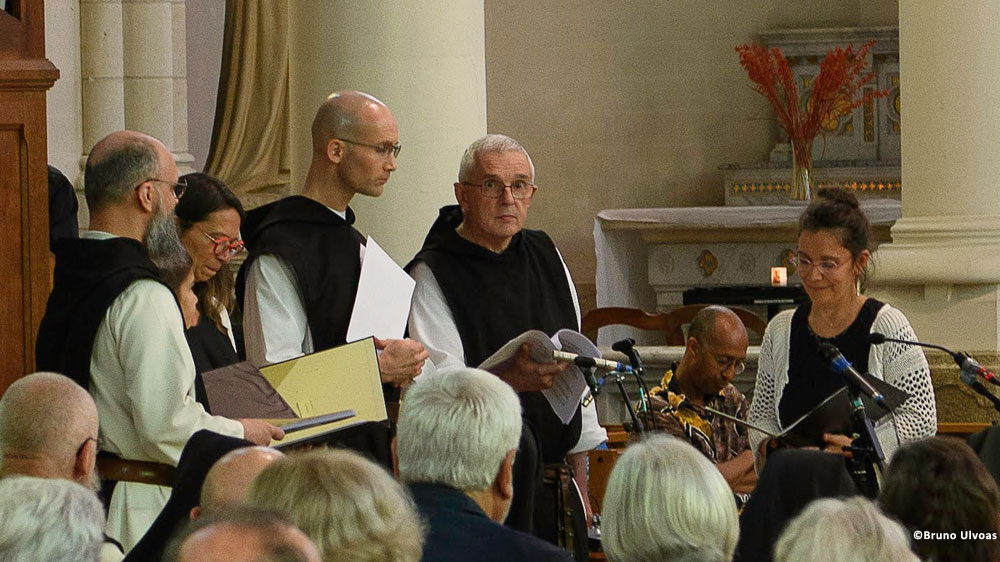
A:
83,133,160,210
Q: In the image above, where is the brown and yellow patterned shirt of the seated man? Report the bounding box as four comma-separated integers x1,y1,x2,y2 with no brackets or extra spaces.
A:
646,370,750,463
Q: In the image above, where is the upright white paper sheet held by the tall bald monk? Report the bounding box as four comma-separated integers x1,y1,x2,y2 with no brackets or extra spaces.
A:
347,236,416,342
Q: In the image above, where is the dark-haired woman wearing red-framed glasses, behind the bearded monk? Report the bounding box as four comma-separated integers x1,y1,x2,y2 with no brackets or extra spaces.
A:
174,173,243,407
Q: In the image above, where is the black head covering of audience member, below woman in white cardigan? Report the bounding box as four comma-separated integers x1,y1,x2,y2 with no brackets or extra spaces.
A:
735,449,858,562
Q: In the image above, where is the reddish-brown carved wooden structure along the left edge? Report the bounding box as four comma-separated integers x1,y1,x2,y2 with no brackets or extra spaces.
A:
0,0,59,393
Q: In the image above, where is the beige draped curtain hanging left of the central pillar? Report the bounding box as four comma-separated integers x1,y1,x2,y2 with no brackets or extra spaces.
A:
205,0,290,208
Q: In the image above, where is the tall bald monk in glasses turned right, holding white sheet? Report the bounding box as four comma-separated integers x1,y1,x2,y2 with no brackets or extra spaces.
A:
244,91,427,386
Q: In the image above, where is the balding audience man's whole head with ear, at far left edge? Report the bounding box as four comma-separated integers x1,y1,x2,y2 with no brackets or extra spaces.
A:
0,372,98,490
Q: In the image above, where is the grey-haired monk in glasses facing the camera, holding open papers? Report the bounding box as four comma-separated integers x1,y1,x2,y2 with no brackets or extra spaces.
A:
407,135,607,540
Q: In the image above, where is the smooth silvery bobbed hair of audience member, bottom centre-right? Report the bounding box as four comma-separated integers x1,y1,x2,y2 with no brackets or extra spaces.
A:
601,435,739,562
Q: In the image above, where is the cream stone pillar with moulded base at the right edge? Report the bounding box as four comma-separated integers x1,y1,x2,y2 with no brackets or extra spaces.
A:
871,0,1000,351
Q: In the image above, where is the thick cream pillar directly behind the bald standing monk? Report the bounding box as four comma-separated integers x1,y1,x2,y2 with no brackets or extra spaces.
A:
288,0,486,263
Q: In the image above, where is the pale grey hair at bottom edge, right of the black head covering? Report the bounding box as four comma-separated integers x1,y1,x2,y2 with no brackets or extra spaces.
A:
774,497,919,562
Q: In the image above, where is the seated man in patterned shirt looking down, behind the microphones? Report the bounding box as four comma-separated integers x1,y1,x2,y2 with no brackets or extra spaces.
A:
649,306,757,495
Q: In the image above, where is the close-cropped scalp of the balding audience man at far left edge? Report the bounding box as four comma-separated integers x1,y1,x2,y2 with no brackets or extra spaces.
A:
0,372,97,463
